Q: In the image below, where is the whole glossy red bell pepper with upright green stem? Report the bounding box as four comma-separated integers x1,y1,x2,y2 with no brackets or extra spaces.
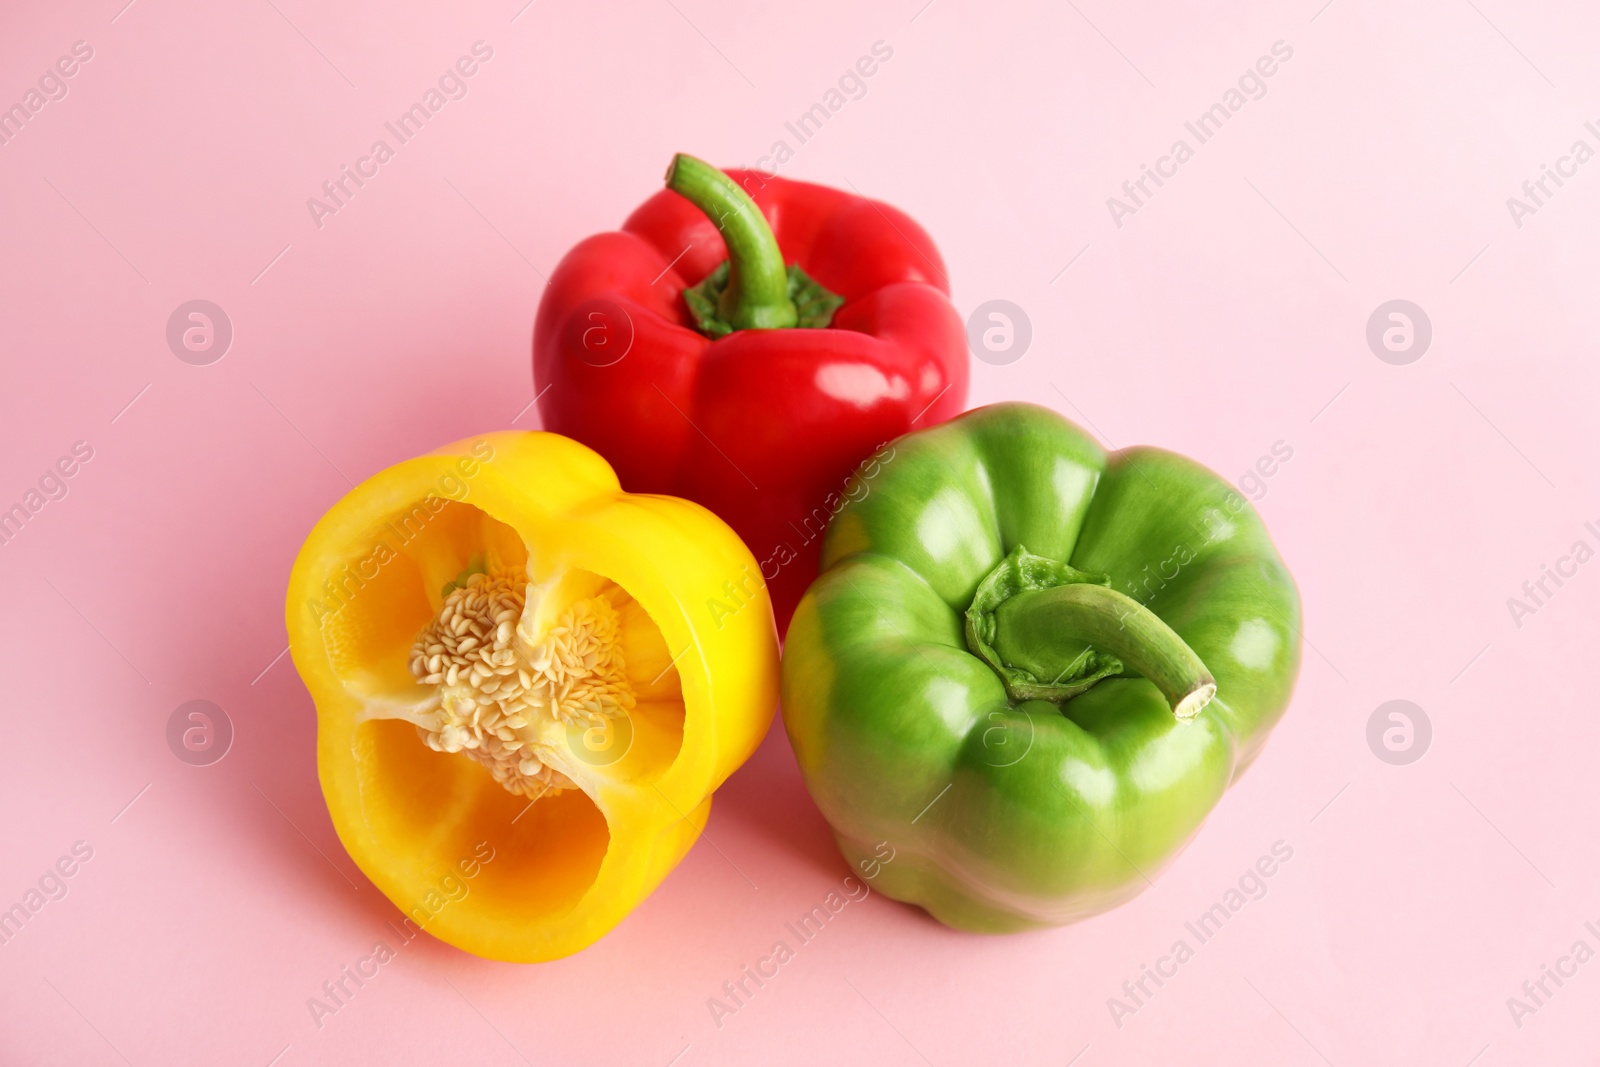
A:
533,157,966,633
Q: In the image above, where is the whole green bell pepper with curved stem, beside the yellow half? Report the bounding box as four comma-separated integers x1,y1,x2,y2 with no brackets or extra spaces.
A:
782,403,1299,931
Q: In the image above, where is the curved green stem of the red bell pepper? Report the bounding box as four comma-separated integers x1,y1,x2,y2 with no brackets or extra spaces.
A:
667,152,798,330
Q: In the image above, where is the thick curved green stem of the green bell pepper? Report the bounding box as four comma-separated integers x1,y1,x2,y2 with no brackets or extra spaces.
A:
994,582,1216,720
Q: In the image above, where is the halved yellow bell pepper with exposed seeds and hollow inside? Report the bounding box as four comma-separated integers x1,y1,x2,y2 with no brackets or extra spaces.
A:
286,432,778,961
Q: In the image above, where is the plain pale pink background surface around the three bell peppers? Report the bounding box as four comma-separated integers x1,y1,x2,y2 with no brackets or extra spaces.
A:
0,0,1600,1067
